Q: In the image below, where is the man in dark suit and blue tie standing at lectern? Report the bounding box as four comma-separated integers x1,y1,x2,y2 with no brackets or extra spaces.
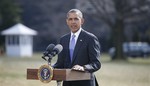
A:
53,9,101,86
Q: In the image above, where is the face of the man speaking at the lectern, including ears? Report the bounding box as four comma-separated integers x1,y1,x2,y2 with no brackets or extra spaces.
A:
66,12,84,33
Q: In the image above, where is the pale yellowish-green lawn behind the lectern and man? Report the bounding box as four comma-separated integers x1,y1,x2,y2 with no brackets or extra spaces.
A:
0,53,150,86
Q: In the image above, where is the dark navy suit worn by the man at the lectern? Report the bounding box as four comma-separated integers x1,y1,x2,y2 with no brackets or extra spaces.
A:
53,30,101,86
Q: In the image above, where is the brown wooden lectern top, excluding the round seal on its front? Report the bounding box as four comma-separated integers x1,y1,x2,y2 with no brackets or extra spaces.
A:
27,69,91,81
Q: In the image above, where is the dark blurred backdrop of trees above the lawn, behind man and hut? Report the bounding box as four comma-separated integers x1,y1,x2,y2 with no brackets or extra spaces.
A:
0,0,150,57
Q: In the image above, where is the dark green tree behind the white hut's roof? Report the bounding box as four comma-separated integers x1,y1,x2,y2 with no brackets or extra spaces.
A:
0,0,21,45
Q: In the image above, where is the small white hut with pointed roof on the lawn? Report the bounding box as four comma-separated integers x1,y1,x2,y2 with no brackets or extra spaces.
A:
1,23,37,57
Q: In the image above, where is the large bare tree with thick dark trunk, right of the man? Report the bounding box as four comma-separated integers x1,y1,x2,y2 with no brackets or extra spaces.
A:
89,0,150,60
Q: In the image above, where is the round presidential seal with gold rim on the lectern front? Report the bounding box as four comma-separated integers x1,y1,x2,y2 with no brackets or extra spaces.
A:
38,65,53,83
